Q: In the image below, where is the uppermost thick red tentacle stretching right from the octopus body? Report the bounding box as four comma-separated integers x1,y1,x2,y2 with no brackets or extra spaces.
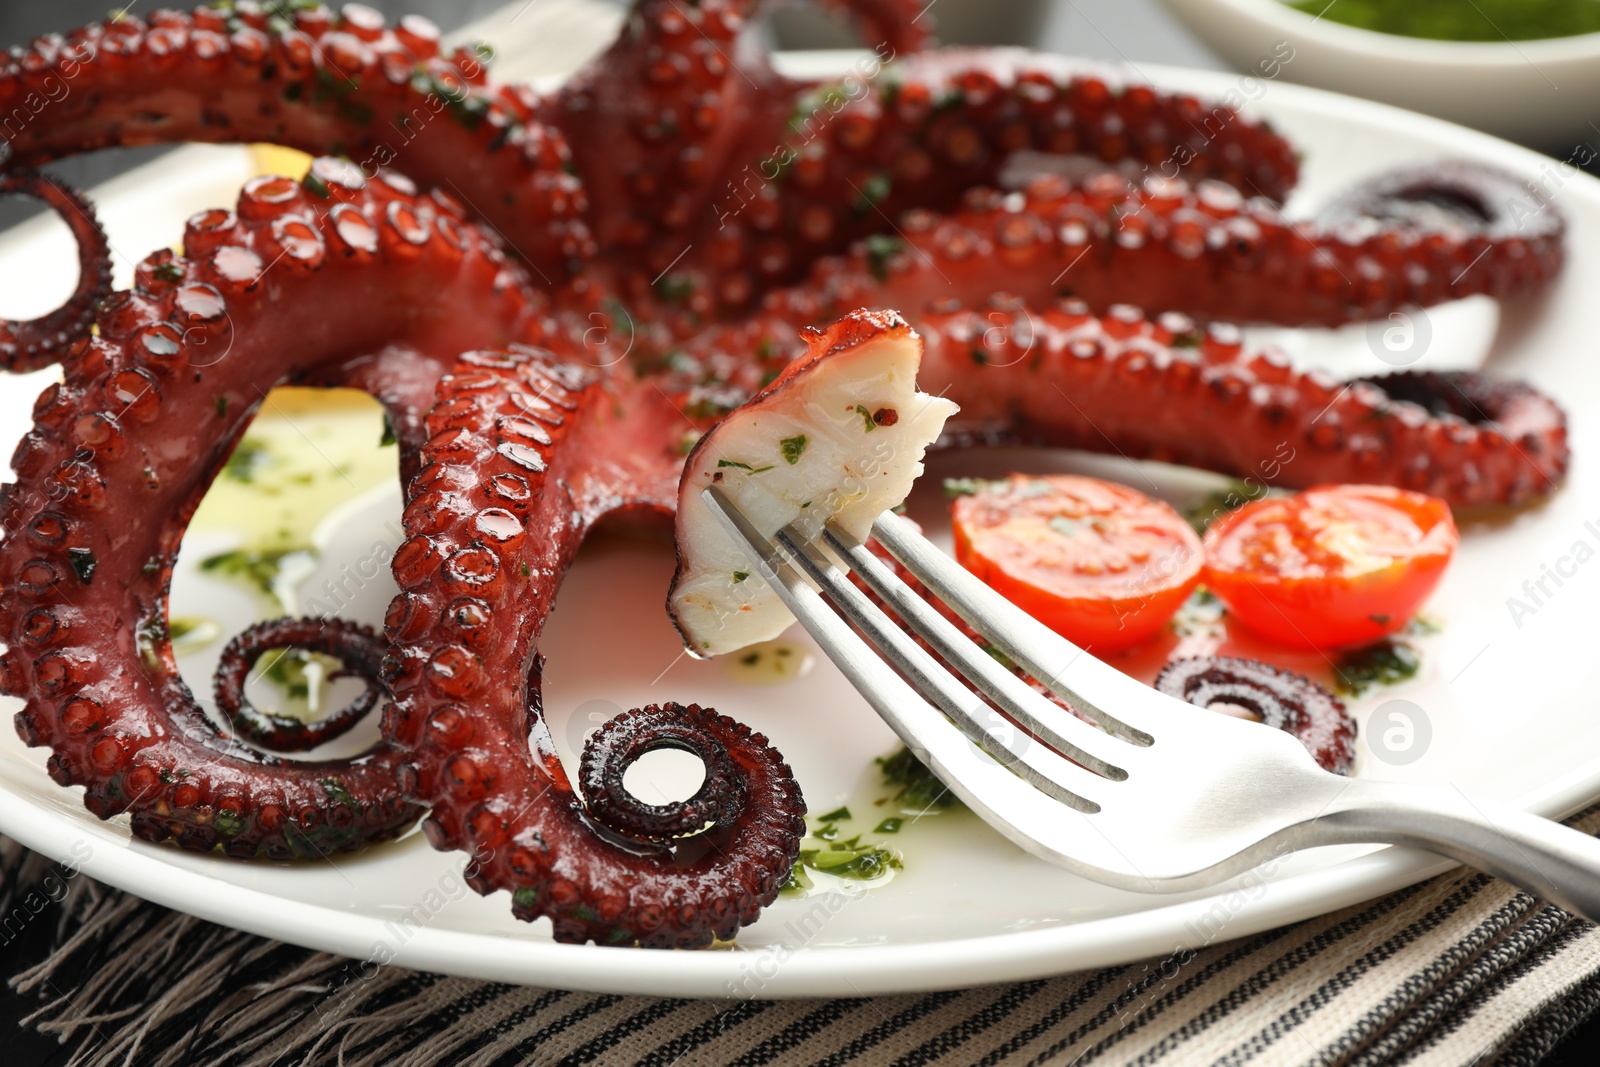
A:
563,41,1298,317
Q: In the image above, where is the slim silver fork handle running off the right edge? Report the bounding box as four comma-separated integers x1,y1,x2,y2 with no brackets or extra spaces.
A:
1307,782,1600,921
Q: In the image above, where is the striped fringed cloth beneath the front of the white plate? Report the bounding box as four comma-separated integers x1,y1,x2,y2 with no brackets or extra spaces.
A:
9,808,1600,1067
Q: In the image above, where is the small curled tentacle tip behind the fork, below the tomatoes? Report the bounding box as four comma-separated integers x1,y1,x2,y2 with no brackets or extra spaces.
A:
1155,656,1355,774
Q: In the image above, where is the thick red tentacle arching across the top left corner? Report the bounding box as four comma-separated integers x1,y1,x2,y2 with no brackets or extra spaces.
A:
0,5,594,278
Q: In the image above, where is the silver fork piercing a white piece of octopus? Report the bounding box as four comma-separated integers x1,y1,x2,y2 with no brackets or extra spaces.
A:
706,486,1600,920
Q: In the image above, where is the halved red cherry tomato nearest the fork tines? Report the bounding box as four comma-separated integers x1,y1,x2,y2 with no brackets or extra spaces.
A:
952,475,1203,654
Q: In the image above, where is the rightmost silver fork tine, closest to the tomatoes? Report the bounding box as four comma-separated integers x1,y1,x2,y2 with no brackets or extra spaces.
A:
872,512,1157,745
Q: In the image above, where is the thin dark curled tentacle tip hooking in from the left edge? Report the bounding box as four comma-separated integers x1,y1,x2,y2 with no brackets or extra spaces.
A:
0,171,110,371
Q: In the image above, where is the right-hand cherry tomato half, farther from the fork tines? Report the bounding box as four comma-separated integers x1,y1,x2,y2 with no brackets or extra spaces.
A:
1205,485,1461,649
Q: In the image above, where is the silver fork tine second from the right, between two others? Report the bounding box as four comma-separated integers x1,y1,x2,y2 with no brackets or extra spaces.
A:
822,525,1136,782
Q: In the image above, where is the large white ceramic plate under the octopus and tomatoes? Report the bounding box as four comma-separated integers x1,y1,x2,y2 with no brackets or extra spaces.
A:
0,59,1600,997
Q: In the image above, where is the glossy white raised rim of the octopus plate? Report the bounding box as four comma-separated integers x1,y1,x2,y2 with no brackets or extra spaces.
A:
0,51,1600,1000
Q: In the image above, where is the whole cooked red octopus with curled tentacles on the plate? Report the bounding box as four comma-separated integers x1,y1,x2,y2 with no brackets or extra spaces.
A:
0,0,1566,945
